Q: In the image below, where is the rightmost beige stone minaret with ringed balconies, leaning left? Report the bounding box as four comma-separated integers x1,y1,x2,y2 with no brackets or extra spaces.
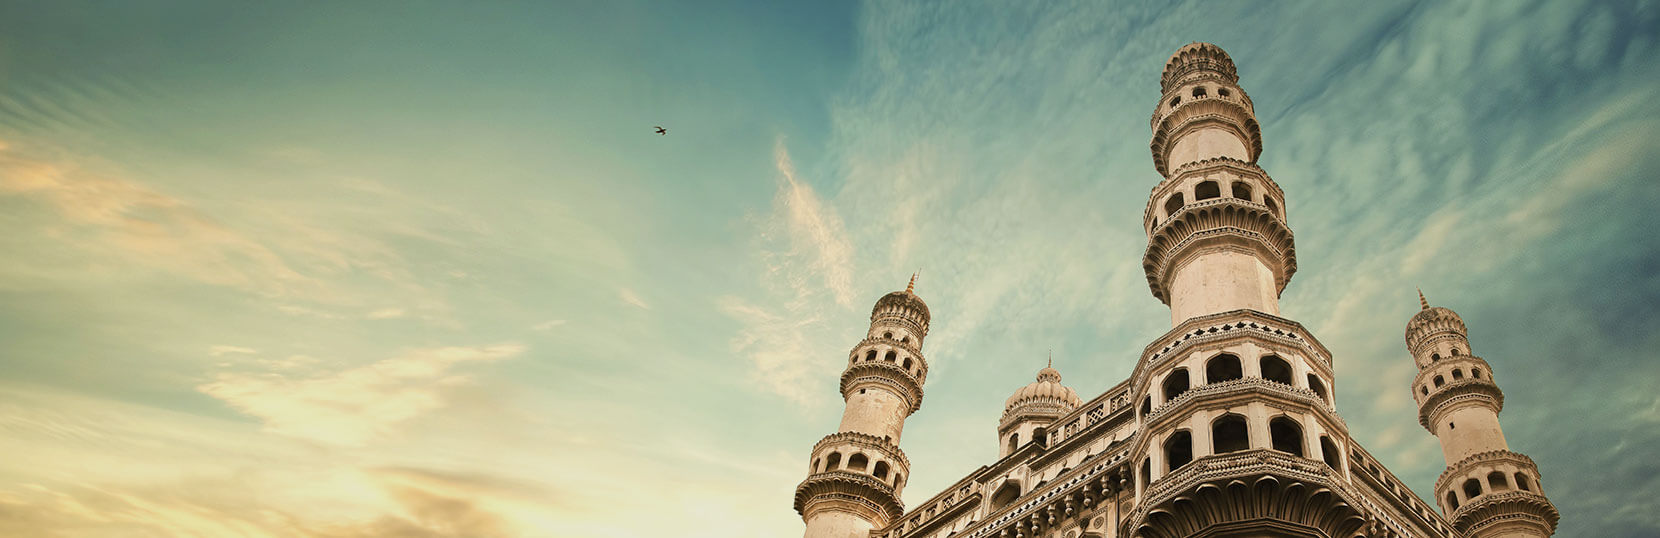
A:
1406,292,1559,538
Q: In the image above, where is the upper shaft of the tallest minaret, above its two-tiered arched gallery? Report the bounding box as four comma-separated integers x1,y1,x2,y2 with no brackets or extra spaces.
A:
1142,43,1296,325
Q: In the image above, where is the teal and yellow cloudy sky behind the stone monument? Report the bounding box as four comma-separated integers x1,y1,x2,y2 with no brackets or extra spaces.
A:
0,0,1660,538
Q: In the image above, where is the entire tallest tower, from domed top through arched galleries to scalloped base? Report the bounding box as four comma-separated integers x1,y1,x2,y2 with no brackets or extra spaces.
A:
1124,43,1371,538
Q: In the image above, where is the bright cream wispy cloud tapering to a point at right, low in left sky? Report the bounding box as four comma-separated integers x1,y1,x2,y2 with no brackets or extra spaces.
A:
198,344,525,445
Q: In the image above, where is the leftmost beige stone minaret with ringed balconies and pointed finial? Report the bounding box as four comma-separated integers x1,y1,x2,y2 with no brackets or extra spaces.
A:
795,274,928,538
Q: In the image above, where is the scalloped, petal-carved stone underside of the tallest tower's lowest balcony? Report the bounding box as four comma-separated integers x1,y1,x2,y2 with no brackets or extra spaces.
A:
1125,450,1370,538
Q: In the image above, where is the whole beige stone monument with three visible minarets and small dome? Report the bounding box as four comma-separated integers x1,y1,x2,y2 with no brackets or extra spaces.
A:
795,43,1559,538
